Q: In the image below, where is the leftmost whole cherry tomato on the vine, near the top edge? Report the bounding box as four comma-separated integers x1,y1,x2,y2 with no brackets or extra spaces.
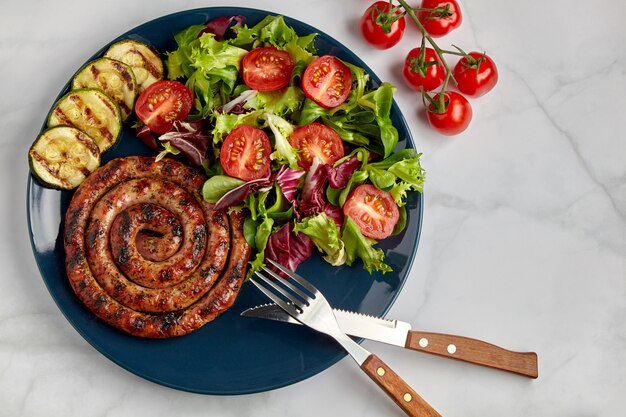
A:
361,1,406,49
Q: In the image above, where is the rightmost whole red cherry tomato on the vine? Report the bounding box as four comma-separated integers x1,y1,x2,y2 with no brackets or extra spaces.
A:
454,52,498,97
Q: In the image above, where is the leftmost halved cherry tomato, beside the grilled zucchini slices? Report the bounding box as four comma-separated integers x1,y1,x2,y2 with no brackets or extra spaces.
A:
135,80,193,133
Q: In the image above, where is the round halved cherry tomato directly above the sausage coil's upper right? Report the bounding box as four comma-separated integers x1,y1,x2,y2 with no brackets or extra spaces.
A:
220,125,272,181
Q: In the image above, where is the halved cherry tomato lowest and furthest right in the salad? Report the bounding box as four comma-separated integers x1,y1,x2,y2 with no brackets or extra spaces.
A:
343,184,400,240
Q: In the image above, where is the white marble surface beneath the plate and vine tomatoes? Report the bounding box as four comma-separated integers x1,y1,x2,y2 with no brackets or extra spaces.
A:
0,0,626,417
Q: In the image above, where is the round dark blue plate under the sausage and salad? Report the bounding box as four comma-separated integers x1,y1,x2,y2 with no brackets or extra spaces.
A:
27,7,423,395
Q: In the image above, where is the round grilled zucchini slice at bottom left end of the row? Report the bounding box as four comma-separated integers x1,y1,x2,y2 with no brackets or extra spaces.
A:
28,126,100,190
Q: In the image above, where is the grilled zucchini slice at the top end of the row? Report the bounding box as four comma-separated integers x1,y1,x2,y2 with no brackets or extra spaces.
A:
104,39,163,94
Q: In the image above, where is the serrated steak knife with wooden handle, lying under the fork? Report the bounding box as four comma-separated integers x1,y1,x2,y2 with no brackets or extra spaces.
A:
241,304,539,378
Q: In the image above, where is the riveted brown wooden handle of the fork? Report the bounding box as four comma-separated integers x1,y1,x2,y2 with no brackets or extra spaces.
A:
361,354,441,417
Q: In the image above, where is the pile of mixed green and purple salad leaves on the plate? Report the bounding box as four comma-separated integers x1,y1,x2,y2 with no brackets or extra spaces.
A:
155,16,424,273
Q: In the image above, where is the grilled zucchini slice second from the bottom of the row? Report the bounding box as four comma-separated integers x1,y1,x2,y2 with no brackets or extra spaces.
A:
48,88,122,153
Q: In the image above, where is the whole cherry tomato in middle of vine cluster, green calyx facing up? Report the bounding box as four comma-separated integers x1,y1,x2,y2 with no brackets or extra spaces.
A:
402,48,445,91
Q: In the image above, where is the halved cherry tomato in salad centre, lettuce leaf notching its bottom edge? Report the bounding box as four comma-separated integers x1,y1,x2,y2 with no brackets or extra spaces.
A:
289,123,344,169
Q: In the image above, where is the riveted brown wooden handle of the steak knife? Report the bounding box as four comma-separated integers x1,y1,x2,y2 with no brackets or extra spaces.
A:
405,331,539,378
